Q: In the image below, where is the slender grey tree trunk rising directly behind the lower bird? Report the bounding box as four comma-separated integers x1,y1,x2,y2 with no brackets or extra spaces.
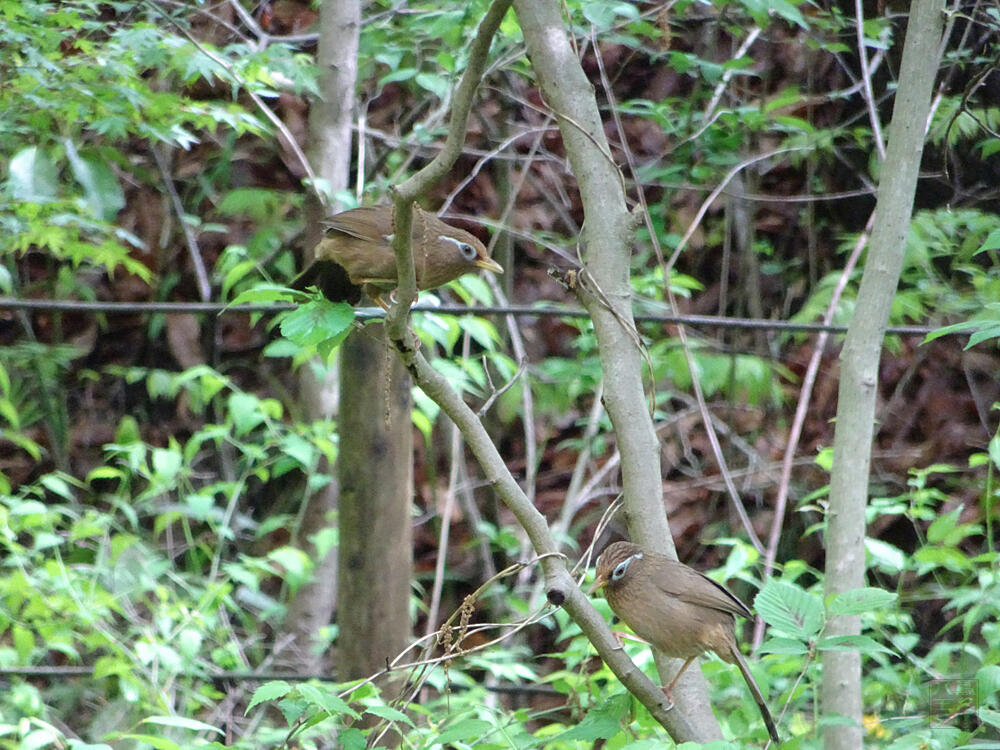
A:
514,0,721,742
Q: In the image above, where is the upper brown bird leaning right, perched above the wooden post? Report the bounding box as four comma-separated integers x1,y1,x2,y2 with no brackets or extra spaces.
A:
292,206,503,309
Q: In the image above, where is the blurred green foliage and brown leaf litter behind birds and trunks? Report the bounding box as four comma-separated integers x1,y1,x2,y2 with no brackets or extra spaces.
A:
0,0,1000,750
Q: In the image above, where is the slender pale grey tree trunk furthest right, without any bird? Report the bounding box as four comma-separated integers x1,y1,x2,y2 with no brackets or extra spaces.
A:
821,0,944,750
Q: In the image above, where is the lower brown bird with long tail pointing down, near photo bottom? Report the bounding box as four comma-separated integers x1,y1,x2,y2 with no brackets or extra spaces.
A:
590,542,779,744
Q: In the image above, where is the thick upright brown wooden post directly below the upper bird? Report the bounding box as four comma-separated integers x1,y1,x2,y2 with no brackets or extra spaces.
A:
337,325,413,688
